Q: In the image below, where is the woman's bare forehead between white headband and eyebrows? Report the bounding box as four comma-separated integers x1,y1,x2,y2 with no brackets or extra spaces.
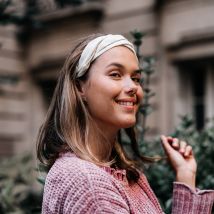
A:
93,46,138,69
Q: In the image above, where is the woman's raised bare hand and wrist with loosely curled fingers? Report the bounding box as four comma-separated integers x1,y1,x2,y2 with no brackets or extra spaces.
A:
161,135,197,189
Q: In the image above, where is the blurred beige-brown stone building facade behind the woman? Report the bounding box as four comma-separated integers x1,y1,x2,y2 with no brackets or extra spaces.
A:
0,0,214,155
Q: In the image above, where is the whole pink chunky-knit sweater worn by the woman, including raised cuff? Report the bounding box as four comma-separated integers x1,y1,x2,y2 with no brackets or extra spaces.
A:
42,153,214,214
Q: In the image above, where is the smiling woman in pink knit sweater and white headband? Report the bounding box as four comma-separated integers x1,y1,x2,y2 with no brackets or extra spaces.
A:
37,35,214,214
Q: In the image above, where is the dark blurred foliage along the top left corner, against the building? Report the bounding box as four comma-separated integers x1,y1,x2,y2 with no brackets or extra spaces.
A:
0,0,89,43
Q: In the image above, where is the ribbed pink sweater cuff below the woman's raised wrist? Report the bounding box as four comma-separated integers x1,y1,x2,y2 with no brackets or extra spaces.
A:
172,182,214,214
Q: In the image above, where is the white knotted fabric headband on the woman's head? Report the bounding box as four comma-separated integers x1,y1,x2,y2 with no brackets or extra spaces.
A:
75,34,136,78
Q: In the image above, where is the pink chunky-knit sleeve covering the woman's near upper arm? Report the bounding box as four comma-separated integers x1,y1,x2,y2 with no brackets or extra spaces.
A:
42,158,129,214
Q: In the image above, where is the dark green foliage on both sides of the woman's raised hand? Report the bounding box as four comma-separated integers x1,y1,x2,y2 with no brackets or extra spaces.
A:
145,116,214,213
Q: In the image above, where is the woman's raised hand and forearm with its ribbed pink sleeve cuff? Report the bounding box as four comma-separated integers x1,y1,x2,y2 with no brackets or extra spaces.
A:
161,136,214,214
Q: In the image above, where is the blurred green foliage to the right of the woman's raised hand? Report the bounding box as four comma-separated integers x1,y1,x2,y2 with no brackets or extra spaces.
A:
174,116,214,189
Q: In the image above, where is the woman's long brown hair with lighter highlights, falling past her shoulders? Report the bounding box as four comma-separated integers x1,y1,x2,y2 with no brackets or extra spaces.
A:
37,34,154,182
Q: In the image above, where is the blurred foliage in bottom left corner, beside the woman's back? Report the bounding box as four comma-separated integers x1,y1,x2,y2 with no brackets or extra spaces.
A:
0,155,42,214
